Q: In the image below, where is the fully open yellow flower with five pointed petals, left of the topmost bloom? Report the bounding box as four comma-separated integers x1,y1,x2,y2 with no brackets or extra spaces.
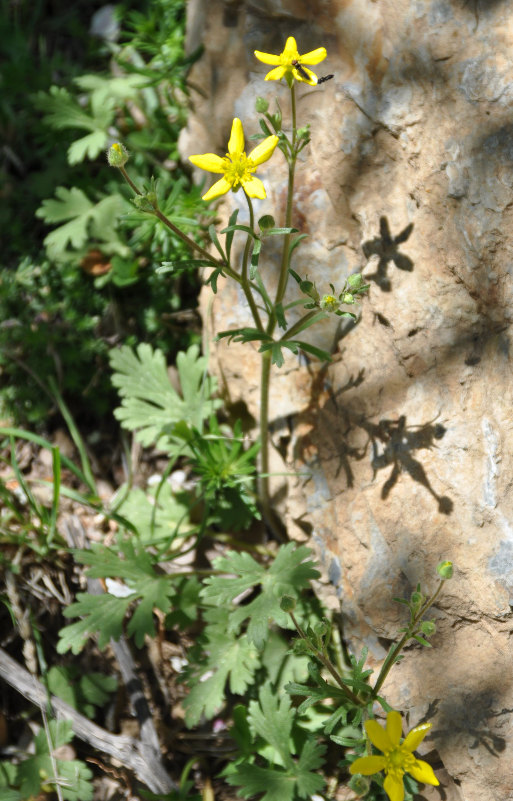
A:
189,117,279,200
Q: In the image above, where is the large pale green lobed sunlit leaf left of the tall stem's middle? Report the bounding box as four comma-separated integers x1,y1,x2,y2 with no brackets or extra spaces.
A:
110,343,220,451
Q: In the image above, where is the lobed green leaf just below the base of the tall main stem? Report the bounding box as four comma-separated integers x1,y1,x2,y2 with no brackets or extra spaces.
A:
201,543,319,650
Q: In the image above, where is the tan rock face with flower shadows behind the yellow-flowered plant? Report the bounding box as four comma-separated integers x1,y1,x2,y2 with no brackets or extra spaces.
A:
182,0,513,801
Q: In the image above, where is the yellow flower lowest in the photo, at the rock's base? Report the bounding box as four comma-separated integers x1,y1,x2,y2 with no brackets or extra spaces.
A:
349,710,440,801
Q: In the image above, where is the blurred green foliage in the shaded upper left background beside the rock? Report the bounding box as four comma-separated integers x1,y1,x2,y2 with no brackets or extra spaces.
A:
0,0,210,426
